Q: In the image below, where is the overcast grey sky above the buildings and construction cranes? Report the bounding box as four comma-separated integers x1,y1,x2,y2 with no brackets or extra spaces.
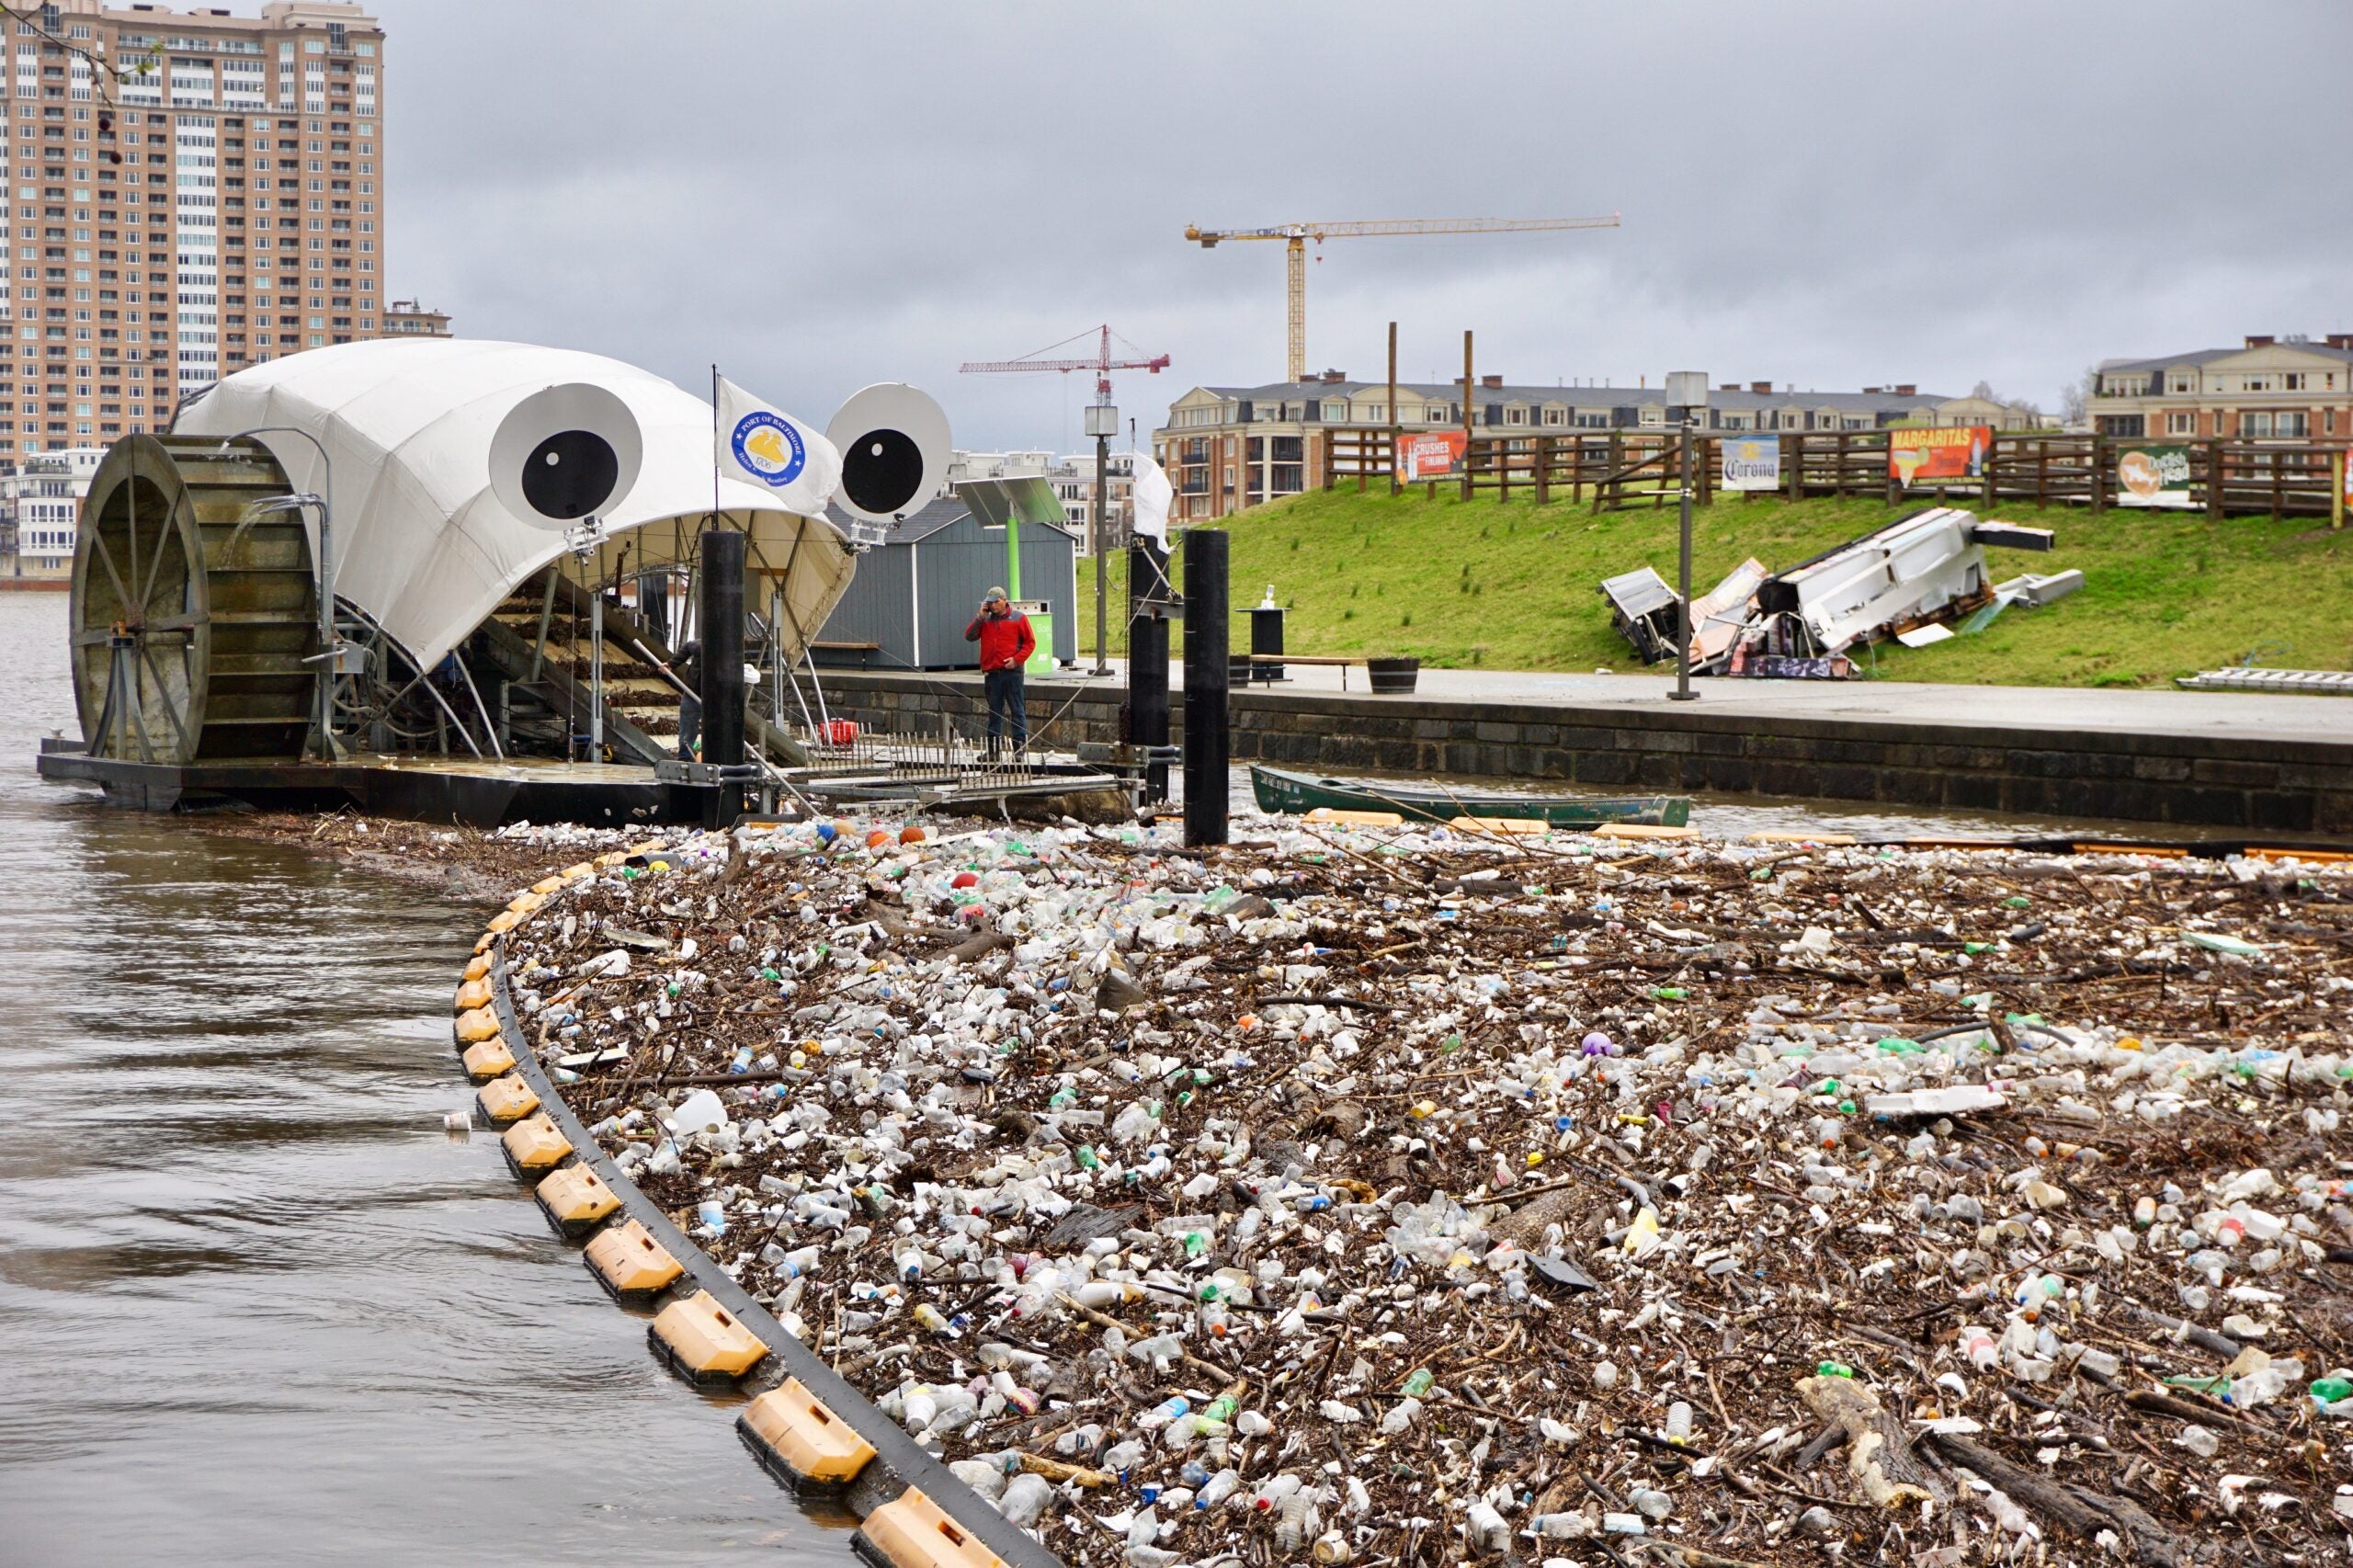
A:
377,0,2353,449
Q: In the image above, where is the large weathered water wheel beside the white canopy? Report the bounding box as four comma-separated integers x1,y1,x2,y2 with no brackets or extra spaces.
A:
71,436,318,766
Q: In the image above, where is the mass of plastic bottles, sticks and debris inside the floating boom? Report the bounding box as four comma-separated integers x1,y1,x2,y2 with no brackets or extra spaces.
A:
472,817,2353,1568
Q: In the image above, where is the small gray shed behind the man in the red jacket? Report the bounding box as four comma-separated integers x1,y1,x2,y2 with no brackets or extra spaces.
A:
810,484,1077,668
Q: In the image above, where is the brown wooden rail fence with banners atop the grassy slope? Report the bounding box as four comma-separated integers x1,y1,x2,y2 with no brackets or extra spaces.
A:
1323,426,2346,520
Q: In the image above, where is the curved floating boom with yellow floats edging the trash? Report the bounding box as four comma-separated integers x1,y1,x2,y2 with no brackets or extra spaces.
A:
452,927,1062,1568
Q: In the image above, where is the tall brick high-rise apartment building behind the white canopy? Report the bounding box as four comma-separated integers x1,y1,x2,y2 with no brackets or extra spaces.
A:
0,0,383,464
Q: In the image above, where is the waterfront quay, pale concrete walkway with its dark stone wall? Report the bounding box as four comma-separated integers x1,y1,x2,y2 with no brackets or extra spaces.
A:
826,664,2353,838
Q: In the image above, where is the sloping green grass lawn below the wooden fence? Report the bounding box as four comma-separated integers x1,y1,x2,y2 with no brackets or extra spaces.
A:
1080,490,2353,685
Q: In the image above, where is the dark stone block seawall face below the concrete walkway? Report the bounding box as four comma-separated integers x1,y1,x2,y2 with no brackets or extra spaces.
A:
826,671,2353,834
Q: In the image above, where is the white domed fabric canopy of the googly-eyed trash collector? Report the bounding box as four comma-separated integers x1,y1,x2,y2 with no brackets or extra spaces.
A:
172,339,857,668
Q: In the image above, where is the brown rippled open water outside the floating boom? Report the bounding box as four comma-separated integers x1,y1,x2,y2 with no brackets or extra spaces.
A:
0,594,849,1565
